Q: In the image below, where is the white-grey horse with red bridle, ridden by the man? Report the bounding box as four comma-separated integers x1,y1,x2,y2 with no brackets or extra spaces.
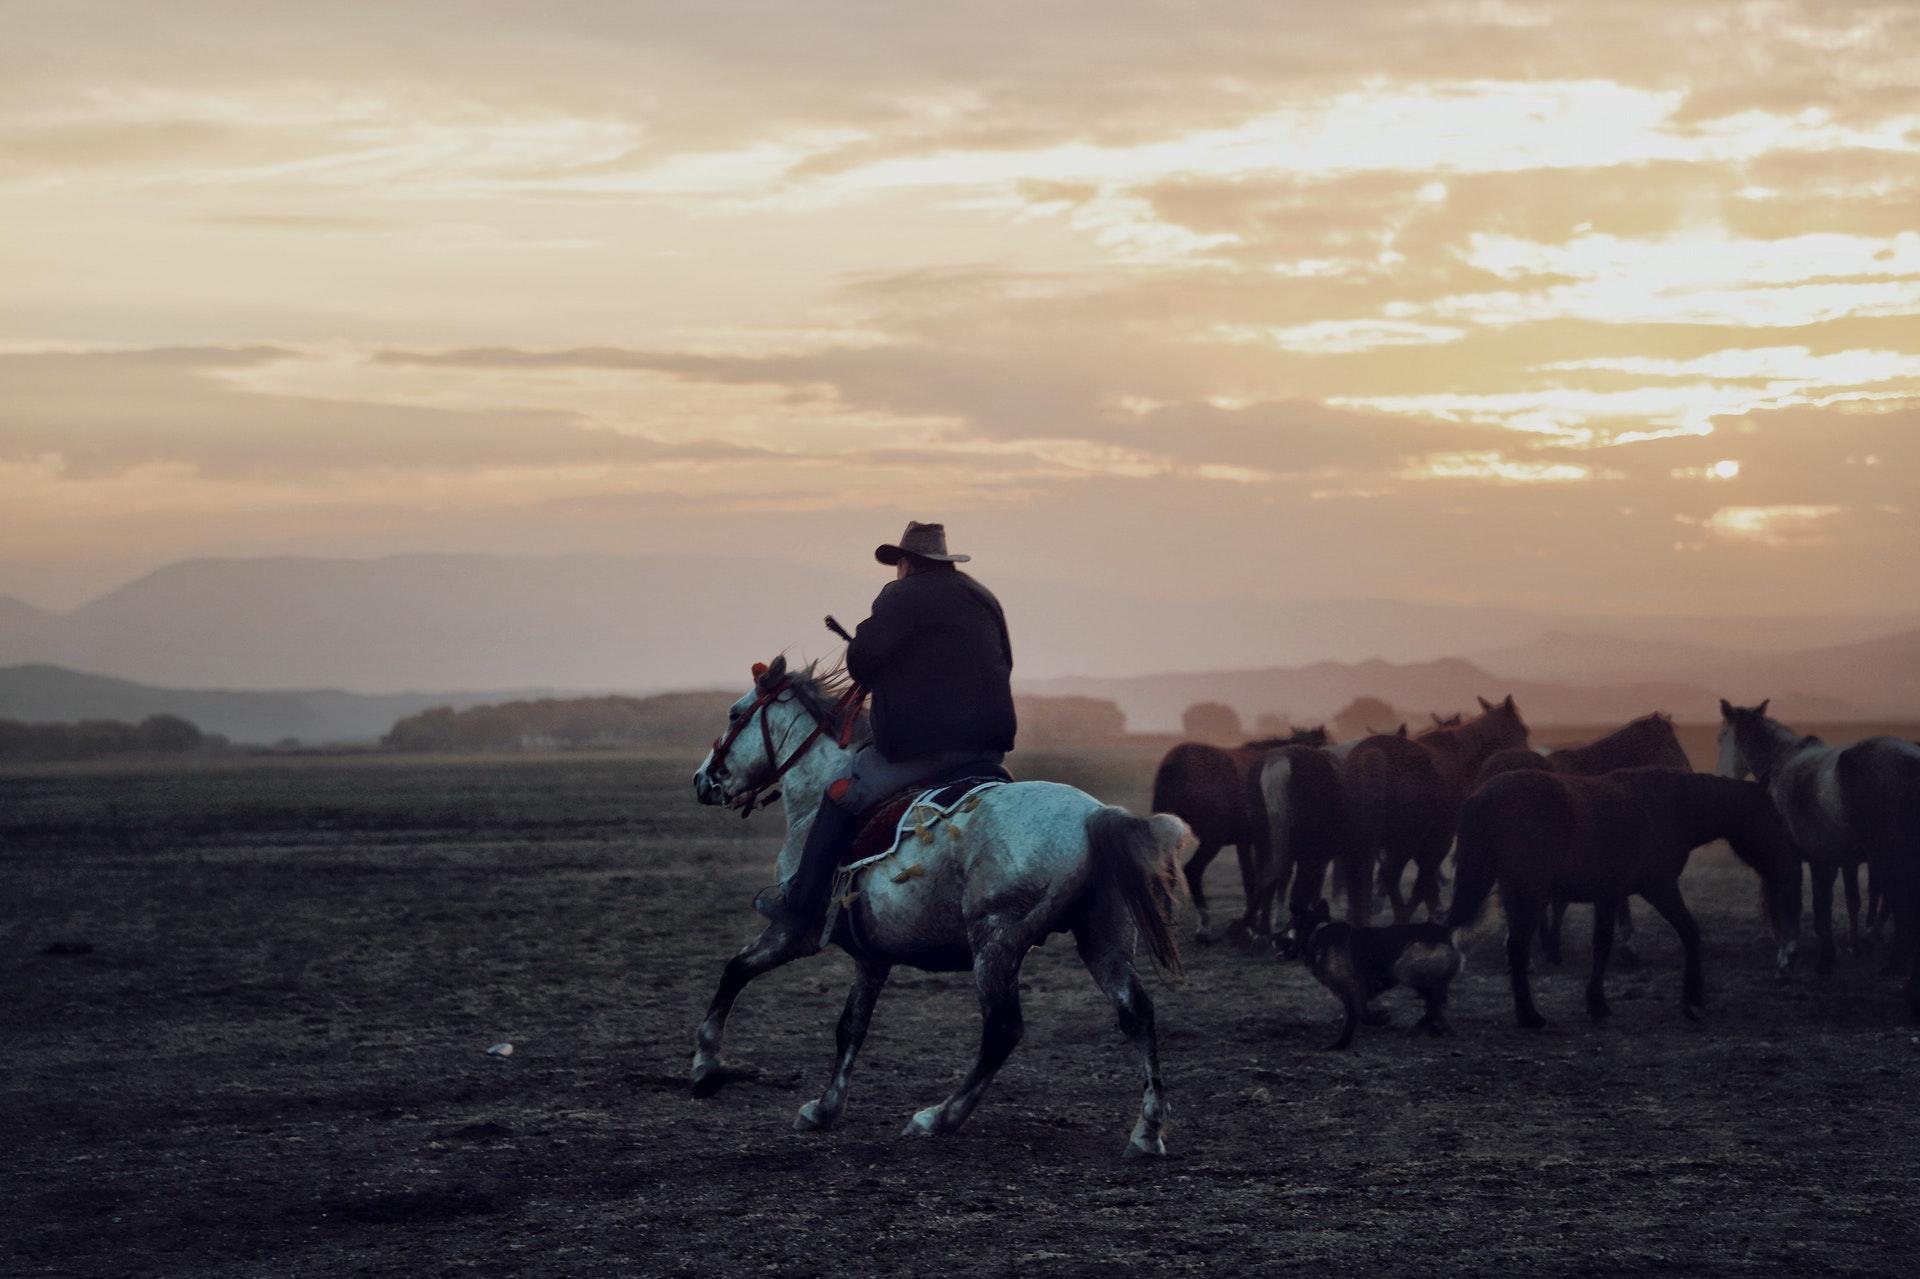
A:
693,659,1187,1158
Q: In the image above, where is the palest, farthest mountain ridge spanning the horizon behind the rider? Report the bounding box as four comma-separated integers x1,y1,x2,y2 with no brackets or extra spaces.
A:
0,553,1920,695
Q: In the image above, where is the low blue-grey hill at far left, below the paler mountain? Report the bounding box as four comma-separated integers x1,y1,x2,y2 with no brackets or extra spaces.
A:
0,664,560,745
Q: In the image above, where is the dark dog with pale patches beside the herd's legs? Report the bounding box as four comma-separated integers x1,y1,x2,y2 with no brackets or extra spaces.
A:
1279,897,1463,1049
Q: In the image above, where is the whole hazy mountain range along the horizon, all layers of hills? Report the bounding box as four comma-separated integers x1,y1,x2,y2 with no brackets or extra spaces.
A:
0,553,1920,741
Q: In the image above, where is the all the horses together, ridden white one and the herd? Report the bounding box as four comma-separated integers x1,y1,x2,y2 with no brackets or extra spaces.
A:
693,659,1920,1158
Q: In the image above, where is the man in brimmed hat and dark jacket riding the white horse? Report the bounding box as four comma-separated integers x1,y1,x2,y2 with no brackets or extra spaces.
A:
753,522,1016,951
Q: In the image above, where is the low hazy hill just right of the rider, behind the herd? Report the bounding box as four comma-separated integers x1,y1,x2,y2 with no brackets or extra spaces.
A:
1029,659,1864,732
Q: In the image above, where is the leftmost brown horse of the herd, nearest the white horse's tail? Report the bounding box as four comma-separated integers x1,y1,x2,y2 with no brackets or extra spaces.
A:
1152,728,1327,941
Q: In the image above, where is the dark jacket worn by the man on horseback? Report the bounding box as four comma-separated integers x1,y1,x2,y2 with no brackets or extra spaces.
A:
847,568,1014,759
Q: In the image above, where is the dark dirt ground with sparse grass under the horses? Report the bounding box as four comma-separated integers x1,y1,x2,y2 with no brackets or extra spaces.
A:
0,749,1920,1275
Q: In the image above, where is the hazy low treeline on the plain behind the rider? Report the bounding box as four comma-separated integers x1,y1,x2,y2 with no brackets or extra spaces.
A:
380,691,1127,751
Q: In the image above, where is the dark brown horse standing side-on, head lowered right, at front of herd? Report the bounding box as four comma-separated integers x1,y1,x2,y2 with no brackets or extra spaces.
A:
1448,768,1799,1029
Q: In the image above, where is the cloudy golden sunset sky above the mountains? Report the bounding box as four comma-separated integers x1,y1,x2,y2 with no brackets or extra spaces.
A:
0,0,1920,615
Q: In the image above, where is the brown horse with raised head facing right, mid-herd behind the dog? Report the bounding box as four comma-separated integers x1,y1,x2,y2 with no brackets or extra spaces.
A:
1344,695,1526,924
